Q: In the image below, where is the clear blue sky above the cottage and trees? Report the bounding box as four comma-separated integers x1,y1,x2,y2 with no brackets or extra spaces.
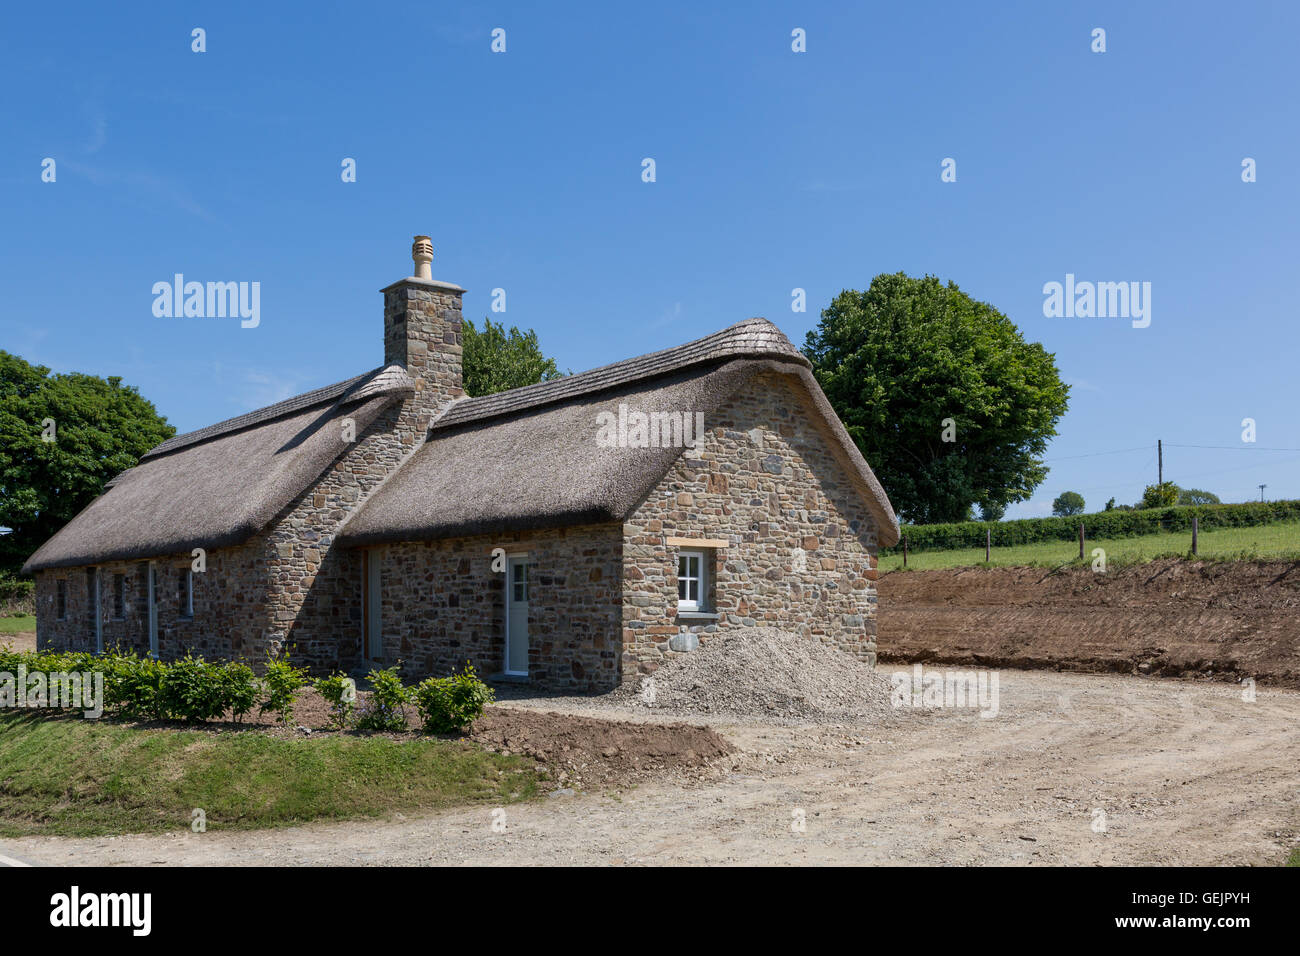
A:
0,3,1300,518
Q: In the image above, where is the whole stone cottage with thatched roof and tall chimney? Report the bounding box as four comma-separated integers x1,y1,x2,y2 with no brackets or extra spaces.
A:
25,237,898,691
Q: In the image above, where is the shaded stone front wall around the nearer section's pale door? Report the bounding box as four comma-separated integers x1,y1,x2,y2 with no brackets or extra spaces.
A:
338,524,623,691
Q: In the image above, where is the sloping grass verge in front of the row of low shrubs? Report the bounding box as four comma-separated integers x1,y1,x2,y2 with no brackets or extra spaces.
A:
0,713,541,836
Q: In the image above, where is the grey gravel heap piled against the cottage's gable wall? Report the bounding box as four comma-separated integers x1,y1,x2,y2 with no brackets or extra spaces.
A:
619,628,893,721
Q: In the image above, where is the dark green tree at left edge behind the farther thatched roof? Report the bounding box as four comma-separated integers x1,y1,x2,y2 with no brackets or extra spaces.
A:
0,351,176,571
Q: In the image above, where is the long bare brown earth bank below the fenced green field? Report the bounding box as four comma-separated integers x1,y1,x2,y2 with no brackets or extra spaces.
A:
878,559,1300,687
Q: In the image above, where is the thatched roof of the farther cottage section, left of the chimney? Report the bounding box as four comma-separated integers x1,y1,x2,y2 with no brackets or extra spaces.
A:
23,365,415,574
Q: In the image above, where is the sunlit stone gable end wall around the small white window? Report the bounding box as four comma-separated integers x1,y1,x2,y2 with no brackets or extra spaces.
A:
623,373,876,683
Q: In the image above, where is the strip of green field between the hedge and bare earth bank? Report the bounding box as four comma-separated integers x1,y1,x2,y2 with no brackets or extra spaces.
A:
880,522,1300,571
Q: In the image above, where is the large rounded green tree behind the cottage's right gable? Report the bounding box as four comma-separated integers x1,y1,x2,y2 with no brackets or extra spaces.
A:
803,272,1070,524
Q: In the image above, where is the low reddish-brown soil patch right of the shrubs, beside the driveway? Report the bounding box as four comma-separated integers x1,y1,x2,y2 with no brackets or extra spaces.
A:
469,708,732,786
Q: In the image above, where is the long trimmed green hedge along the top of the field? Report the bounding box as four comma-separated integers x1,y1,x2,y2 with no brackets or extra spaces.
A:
880,501,1300,554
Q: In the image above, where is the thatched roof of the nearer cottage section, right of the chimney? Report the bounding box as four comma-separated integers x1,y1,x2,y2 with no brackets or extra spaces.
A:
338,319,898,546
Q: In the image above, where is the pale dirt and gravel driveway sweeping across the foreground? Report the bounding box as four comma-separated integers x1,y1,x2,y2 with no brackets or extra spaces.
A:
0,671,1300,865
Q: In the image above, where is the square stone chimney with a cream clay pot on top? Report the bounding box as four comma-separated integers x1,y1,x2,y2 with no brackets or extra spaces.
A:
384,235,465,419
